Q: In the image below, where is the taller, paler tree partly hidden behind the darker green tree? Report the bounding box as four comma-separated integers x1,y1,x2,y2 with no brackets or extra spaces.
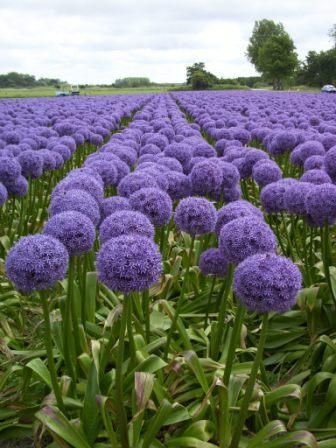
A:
247,19,285,72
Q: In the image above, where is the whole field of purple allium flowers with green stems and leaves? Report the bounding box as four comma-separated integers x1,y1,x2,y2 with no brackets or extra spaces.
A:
0,91,336,448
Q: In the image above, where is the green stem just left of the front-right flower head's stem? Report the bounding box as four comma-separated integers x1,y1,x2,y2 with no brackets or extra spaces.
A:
219,305,245,448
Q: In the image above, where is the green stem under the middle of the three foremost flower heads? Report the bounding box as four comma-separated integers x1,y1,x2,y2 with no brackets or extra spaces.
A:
115,296,131,448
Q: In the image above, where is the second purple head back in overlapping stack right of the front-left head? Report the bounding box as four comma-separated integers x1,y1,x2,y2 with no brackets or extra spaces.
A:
49,190,100,226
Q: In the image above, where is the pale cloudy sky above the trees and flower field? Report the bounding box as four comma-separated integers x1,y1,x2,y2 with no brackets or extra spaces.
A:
0,0,335,83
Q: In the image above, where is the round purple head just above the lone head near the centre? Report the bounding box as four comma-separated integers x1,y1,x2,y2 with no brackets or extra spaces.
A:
189,160,223,196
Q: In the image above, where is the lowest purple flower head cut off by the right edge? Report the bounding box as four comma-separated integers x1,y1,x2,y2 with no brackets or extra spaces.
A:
306,184,336,227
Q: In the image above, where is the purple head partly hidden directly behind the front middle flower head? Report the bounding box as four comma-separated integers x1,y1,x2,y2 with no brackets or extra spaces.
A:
99,210,154,243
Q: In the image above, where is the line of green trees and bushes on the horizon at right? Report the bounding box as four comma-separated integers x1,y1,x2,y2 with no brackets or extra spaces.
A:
187,19,336,90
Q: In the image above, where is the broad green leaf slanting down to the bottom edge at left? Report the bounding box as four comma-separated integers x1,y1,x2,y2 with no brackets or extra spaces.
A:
36,406,91,448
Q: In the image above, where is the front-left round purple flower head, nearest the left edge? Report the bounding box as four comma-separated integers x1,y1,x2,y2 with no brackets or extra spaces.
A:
5,235,69,293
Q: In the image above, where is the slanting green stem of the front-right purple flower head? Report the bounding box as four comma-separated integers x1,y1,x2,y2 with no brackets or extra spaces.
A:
230,313,268,448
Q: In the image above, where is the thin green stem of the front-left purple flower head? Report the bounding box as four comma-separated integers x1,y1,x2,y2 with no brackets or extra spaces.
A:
40,291,65,413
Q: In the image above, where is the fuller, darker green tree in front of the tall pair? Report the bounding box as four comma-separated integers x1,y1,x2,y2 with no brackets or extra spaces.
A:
258,33,298,90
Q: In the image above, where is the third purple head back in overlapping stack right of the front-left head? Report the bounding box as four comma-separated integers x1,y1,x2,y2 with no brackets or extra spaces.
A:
51,171,104,204
